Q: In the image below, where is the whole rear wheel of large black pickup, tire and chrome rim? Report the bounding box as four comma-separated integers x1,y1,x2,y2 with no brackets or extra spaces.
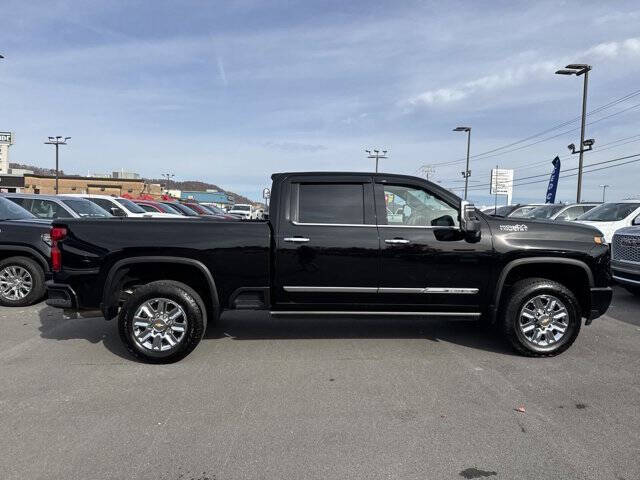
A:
118,280,207,363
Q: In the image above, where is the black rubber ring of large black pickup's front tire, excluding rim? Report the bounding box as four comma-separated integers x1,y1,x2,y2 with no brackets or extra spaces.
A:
505,280,582,356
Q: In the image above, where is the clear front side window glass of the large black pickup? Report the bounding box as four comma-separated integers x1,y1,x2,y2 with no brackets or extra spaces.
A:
384,185,459,227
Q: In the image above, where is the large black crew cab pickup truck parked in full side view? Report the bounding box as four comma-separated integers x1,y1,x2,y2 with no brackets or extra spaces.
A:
47,172,612,362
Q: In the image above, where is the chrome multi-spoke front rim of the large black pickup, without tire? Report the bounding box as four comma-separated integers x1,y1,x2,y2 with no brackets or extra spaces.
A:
518,295,569,347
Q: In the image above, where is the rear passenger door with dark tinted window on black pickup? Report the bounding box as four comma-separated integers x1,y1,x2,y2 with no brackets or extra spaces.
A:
274,175,380,310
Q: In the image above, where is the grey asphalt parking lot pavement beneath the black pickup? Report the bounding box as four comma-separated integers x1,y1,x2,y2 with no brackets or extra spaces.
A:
0,289,640,480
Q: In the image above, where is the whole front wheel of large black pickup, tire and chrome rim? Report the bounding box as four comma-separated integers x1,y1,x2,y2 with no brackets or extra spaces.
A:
501,278,582,357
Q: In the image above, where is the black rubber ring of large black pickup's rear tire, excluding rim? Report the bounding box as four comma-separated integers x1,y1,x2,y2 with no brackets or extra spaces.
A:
118,282,204,363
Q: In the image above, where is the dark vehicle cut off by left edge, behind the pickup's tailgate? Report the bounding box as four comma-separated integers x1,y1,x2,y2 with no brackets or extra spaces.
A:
0,196,51,307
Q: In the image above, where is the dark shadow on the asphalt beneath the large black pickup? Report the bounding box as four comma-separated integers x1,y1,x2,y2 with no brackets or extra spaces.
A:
39,305,515,361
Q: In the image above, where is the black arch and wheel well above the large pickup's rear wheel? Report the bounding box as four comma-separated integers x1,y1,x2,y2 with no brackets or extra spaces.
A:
100,256,220,321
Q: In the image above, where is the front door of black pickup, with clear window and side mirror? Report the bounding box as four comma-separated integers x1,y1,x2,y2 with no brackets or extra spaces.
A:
375,177,493,316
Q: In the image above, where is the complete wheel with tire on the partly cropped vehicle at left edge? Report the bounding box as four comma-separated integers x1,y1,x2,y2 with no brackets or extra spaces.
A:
0,257,46,307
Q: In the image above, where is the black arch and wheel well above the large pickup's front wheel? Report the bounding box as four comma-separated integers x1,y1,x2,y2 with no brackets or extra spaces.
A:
491,257,594,322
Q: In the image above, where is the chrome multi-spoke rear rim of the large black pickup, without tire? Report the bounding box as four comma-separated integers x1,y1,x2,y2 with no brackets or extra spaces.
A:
132,298,187,352
